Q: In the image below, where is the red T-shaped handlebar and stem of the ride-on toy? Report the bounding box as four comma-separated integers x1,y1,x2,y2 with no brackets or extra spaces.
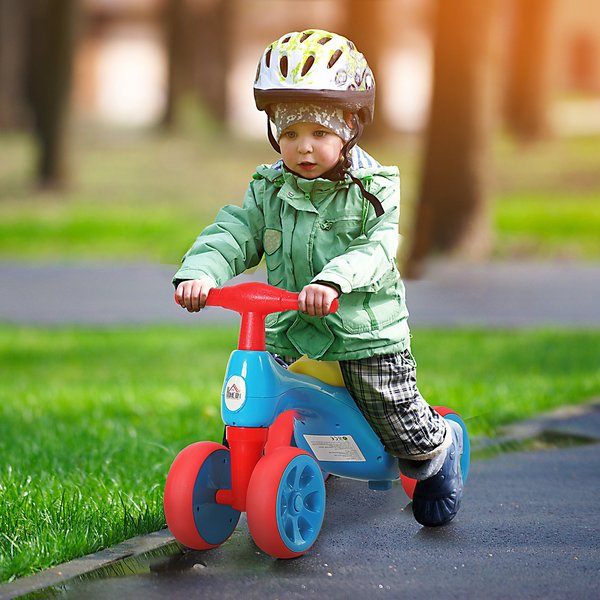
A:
180,282,338,350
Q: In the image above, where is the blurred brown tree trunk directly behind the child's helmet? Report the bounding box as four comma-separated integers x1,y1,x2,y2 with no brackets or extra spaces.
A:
340,0,391,140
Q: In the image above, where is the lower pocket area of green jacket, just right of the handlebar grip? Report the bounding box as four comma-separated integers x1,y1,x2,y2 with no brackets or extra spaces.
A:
339,292,402,333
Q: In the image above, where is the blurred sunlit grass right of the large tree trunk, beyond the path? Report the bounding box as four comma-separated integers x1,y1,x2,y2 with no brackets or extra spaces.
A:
493,136,600,260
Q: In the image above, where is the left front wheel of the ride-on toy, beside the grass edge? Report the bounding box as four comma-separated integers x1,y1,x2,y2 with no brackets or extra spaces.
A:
164,442,240,550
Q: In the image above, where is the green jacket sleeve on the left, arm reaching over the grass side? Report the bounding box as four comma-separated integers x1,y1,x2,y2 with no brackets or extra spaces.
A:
173,182,264,286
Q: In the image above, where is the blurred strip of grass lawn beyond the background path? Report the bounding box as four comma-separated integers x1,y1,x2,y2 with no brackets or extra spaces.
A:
0,128,600,264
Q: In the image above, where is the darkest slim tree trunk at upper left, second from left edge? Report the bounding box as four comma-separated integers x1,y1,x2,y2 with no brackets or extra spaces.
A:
29,0,79,187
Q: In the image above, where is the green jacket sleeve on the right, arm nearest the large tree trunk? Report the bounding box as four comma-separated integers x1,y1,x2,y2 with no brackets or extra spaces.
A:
313,176,400,294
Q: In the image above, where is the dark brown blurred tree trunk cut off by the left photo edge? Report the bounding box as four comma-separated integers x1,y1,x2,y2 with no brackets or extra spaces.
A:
0,0,27,130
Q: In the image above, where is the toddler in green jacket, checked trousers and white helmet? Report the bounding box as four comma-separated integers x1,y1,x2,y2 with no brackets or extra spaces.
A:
173,29,463,526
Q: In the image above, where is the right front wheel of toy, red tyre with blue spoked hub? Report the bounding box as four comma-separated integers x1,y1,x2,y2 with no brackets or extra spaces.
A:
246,447,325,558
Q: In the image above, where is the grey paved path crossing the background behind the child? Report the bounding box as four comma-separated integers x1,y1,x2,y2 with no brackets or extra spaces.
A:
0,262,600,327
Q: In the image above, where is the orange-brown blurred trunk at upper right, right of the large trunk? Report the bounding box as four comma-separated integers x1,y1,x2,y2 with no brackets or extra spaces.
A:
505,0,556,140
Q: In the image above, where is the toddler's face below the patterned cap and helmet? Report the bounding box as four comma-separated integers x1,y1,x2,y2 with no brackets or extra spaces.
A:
279,122,344,179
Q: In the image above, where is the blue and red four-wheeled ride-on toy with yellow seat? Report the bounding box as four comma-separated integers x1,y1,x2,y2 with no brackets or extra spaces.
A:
164,283,469,558
